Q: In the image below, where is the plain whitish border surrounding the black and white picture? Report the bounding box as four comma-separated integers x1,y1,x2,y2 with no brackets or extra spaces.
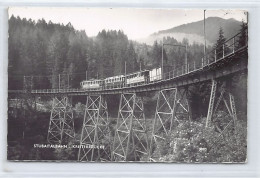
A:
0,0,260,177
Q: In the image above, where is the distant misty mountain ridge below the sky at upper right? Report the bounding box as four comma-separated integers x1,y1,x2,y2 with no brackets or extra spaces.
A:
137,17,242,45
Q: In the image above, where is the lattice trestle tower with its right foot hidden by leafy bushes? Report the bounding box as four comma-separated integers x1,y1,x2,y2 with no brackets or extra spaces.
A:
149,88,191,161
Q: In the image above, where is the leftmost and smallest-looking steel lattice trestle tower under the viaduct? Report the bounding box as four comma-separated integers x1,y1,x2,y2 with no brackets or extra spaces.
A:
47,96,75,144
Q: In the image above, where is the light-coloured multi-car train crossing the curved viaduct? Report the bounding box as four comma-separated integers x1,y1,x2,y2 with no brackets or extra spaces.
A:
80,67,162,90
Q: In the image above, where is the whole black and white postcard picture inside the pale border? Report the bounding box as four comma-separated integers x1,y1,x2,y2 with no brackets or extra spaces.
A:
6,7,250,164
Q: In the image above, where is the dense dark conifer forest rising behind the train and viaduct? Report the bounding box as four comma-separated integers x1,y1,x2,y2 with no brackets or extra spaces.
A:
8,16,244,92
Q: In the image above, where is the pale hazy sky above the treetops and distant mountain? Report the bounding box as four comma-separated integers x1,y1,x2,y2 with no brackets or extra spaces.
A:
9,7,247,39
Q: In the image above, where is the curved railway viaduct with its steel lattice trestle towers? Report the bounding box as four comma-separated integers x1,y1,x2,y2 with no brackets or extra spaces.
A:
8,31,248,161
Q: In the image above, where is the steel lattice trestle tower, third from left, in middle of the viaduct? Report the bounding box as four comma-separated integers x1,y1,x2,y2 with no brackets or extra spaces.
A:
112,93,149,161
